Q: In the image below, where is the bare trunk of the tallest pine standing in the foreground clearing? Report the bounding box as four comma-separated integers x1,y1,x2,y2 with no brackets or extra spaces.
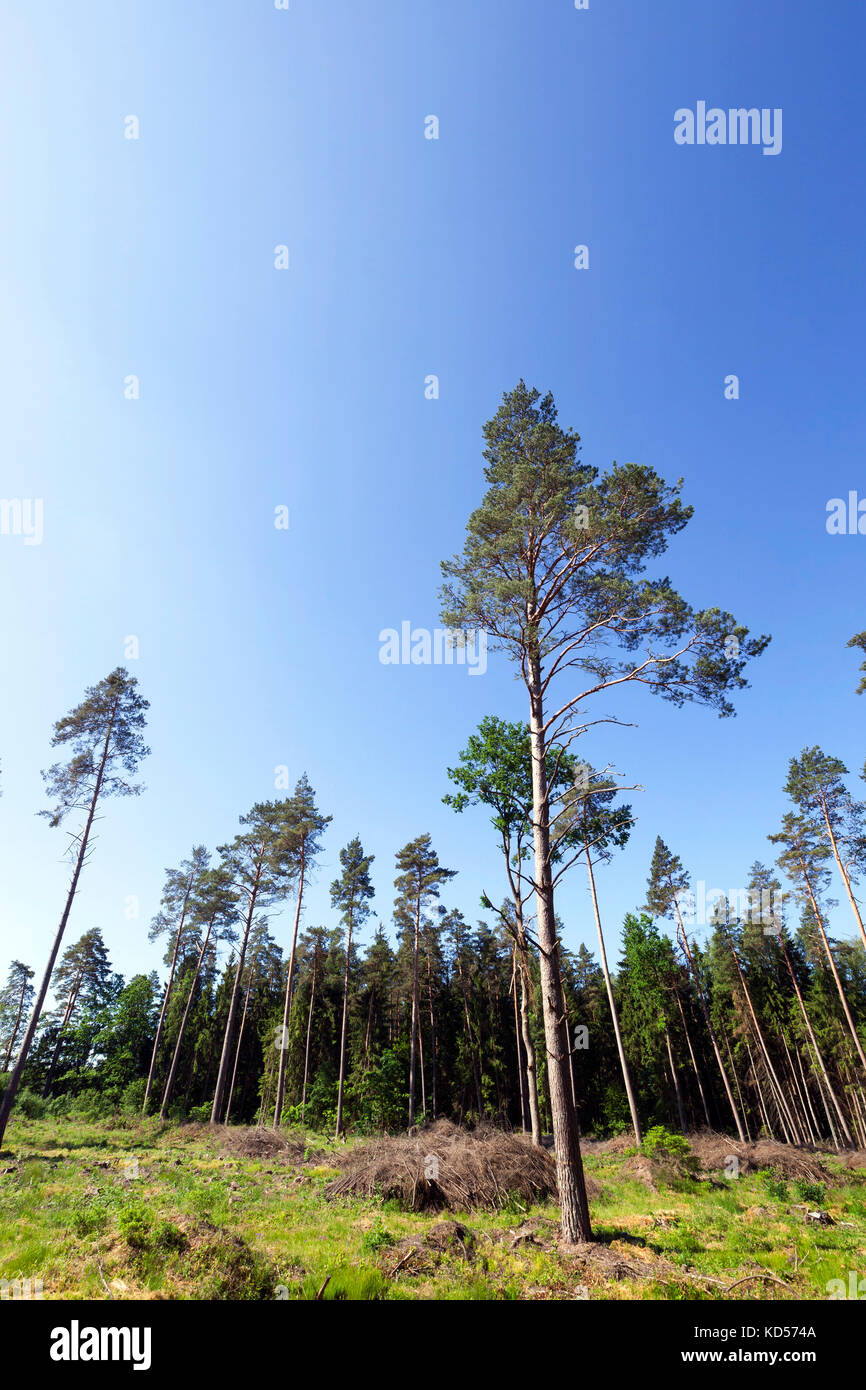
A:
530,653,592,1245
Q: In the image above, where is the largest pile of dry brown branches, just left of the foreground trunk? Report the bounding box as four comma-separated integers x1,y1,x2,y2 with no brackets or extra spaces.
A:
325,1120,572,1211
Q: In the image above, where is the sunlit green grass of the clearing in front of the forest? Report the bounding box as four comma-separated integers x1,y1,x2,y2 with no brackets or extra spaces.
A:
0,1119,866,1301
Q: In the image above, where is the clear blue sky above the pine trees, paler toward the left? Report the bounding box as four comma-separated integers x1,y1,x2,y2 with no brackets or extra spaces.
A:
0,0,866,1000
